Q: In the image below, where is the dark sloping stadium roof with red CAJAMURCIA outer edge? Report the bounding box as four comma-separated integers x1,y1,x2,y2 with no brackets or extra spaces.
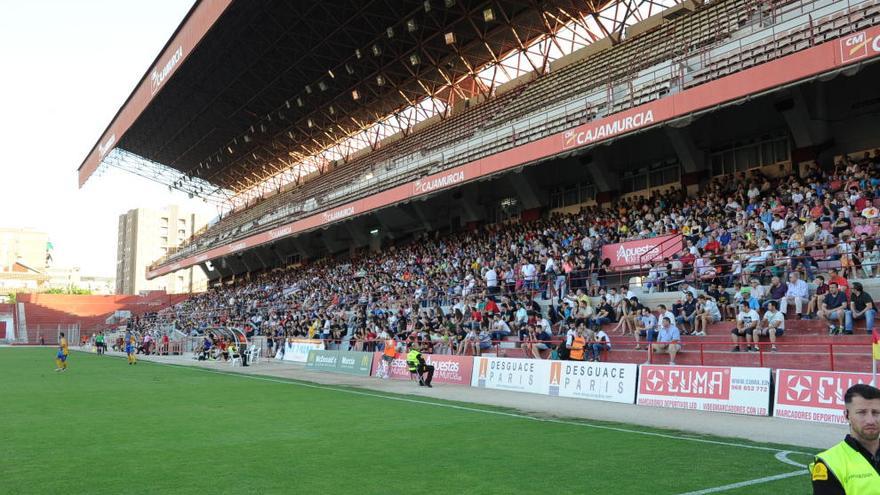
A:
79,0,669,202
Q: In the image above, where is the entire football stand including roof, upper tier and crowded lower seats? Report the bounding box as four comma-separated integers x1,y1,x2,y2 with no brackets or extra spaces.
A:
74,0,880,371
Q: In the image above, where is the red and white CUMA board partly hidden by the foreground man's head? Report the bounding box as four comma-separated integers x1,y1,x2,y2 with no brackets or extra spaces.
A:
773,370,871,425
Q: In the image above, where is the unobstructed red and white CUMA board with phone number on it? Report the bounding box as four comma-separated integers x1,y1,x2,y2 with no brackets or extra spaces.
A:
636,365,770,416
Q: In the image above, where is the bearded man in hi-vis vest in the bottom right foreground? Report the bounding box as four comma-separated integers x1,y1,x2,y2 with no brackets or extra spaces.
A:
810,384,880,495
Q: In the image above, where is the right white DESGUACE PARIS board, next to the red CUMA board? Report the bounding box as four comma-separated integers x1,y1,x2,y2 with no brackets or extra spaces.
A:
548,361,638,404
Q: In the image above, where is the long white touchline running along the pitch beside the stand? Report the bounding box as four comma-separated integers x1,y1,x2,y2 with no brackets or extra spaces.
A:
148,354,814,462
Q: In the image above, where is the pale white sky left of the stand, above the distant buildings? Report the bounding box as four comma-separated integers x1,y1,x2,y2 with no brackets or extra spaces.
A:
0,0,216,276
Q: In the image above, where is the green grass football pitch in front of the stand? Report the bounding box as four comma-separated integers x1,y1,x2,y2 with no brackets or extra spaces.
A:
0,348,810,495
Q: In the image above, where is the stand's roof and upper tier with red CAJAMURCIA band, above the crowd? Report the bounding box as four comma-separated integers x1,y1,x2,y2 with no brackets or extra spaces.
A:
78,0,880,282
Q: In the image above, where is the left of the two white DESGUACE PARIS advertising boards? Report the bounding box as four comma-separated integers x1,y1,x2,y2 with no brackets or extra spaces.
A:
471,357,551,395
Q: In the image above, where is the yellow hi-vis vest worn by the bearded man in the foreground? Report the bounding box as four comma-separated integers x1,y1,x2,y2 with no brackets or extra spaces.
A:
810,441,880,495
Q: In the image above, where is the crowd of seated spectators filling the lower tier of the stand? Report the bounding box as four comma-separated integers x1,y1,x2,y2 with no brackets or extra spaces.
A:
131,151,880,360
